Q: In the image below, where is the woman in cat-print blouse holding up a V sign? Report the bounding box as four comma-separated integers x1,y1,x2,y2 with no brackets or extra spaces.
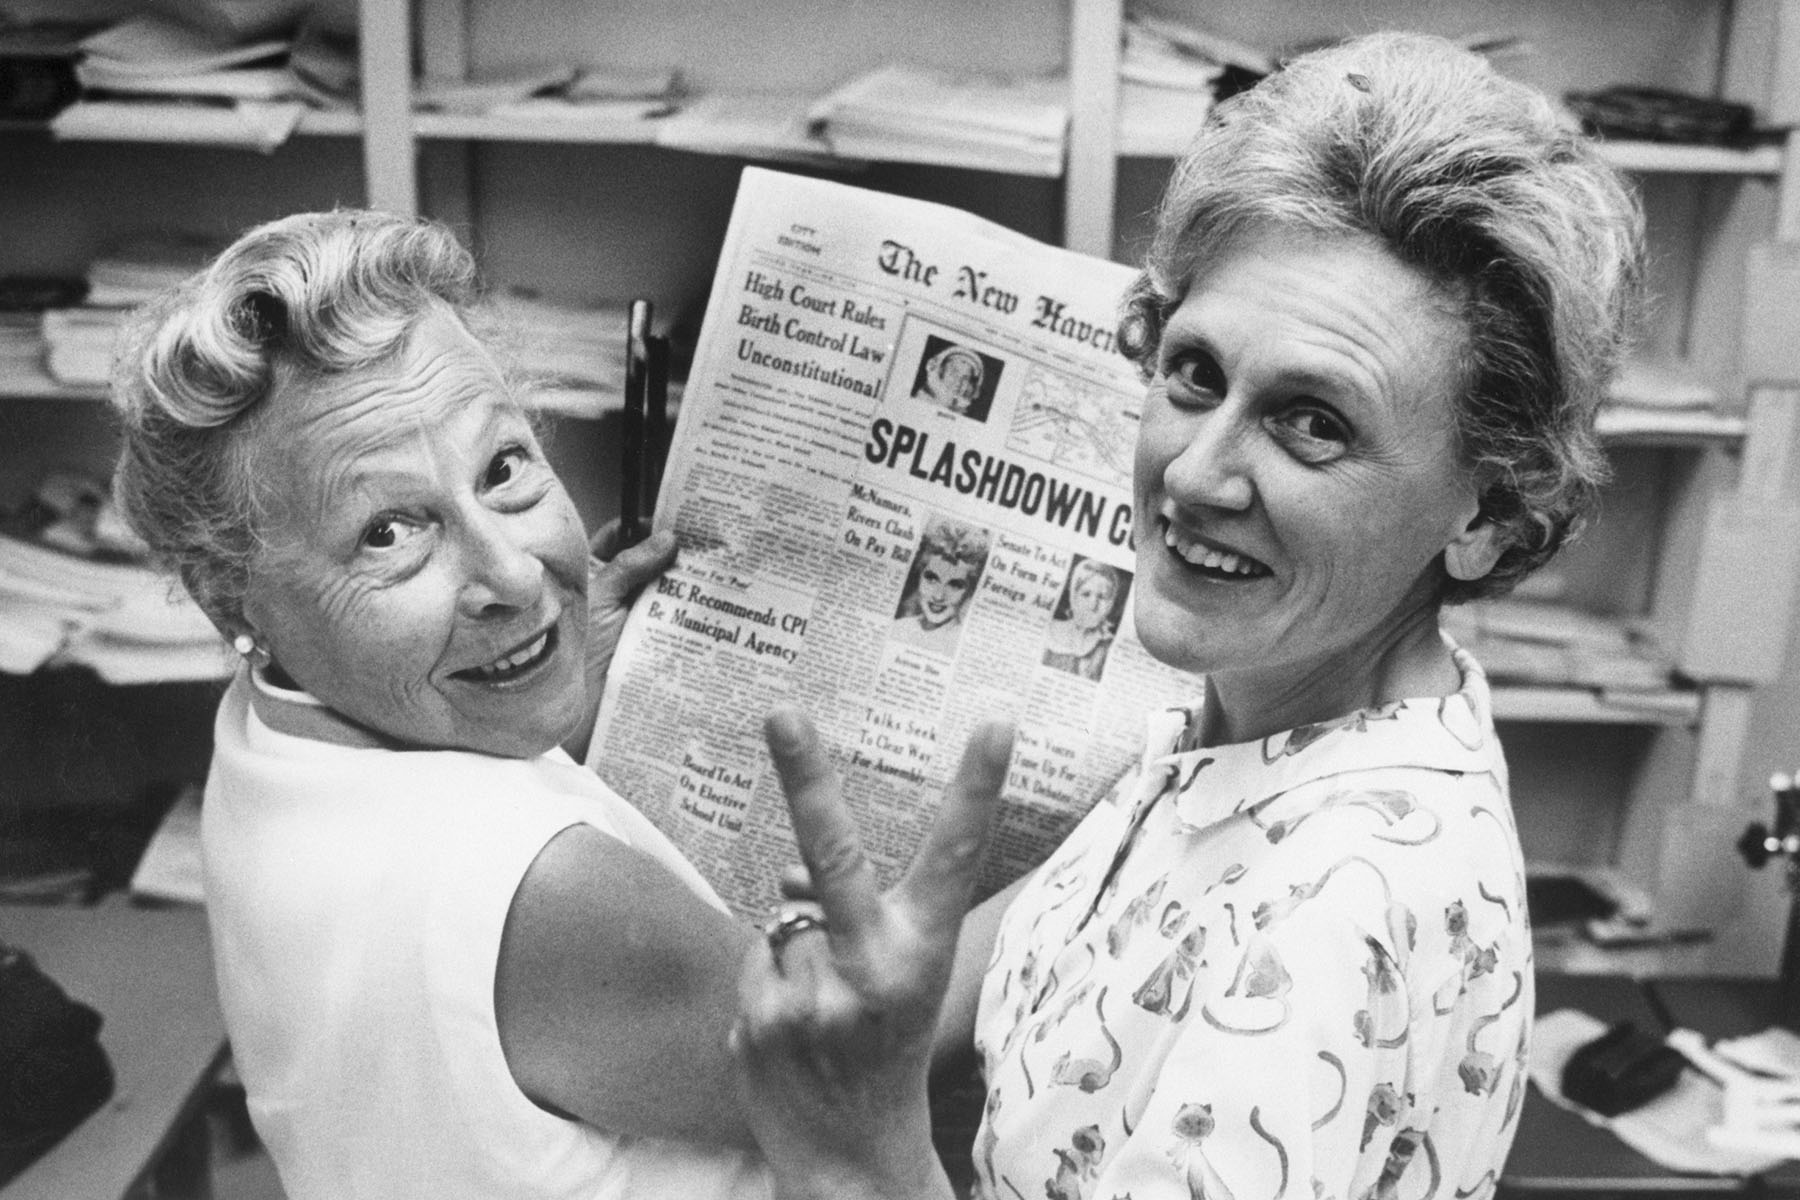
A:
734,34,1642,1200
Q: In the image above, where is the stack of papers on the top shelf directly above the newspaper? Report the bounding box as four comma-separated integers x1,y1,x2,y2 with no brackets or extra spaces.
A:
810,63,1069,176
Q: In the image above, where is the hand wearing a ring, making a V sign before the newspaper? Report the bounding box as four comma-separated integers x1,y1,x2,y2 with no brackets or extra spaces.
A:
731,709,1012,1200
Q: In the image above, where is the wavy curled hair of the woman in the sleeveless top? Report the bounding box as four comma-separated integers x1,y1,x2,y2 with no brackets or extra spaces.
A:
113,210,477,628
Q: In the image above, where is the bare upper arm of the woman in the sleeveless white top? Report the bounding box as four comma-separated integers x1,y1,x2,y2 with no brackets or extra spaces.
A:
493,826,756,1146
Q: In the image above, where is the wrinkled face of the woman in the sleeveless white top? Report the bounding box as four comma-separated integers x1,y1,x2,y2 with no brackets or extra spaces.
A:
245,313,587,757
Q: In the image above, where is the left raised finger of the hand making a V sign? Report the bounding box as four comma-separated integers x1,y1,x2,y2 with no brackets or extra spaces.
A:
763,705,882,943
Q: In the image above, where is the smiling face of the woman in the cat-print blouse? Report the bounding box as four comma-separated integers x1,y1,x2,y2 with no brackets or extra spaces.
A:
1134,230,1478,690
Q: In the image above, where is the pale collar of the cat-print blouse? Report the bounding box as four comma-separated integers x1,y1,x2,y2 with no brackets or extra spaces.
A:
1143,646,1499,828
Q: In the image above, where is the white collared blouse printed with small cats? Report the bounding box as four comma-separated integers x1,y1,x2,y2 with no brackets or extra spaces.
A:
974,649,1532,1200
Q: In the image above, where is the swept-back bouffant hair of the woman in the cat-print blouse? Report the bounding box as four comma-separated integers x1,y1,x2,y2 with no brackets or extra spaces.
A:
1120,32,1643,603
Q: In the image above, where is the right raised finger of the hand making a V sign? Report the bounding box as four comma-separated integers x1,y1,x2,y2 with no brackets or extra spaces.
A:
895,721,1013,930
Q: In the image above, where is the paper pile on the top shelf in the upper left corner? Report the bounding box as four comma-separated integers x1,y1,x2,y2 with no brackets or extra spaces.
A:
50,8,306,151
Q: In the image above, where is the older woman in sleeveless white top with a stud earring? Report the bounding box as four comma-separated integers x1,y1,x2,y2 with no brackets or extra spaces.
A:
115,212,788,1200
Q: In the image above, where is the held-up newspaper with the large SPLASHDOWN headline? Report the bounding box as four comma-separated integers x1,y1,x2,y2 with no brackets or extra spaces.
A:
589,167,1199,918
